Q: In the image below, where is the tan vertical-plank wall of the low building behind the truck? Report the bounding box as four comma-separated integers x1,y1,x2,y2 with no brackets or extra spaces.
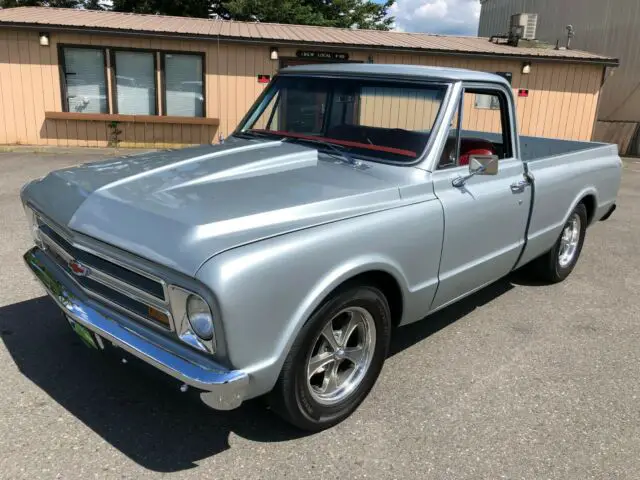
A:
0,29,603,147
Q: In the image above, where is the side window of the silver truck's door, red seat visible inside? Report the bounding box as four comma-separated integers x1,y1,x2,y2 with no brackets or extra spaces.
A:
438,89,513,168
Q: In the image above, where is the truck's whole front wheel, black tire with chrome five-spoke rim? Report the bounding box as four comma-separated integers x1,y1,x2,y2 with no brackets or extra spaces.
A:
269,286,391,431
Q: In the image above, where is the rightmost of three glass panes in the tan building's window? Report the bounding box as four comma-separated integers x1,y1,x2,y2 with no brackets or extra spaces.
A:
164,53,204,117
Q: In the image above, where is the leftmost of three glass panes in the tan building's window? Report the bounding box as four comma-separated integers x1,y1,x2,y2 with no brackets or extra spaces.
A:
62,48,109,113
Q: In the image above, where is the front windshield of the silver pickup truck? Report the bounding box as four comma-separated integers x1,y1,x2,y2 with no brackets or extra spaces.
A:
236,76,447,163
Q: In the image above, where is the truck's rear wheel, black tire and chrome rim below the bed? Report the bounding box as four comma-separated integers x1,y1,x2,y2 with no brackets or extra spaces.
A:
533,203,588,283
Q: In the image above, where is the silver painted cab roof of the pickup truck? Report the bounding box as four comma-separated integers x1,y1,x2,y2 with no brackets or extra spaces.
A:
280,63,508,85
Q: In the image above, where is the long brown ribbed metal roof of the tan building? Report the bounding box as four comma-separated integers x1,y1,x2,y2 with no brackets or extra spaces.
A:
0,7,618,66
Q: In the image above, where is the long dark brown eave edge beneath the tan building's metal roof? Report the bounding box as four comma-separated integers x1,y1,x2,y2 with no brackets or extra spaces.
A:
0,21,620,67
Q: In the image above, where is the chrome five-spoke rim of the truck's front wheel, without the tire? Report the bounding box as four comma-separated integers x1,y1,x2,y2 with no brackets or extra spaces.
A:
307,307,376,405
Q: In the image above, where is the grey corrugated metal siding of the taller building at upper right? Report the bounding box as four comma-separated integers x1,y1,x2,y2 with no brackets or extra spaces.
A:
479,0,640,122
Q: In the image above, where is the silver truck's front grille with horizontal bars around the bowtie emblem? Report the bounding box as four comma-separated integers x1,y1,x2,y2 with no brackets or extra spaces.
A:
38,218,171,329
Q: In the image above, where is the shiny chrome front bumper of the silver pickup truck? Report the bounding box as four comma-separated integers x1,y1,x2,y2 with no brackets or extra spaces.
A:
24,247,249,410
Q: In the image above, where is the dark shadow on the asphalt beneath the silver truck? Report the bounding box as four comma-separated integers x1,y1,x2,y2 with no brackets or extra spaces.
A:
0,274,524,472
